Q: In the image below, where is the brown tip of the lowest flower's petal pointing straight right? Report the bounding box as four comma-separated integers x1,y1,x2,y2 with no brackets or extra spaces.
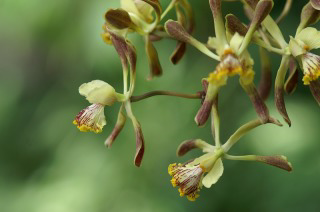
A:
256,155,292,172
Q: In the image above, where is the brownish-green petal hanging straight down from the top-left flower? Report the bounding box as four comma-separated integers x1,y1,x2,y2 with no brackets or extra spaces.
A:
146,37,162,80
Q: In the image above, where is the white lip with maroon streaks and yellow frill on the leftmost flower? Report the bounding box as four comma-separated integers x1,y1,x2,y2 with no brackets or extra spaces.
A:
73,104,107,133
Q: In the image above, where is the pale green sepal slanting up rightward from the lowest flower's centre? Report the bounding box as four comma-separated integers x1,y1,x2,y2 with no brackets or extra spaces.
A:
222,119,262,152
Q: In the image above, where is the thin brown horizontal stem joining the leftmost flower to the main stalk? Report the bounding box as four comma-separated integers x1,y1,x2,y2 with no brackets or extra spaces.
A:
130,91,202,102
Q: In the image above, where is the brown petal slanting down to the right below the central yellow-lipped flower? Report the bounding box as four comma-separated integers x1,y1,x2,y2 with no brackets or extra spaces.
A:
240,80,269,124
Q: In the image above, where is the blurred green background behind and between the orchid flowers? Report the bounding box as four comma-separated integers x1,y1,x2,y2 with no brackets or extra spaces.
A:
0,0,320,212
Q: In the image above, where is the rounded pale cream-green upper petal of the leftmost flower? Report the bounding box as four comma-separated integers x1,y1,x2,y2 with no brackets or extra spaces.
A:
79,80,117,106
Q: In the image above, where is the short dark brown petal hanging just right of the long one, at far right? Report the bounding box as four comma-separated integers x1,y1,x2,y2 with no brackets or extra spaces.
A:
284,57,299,94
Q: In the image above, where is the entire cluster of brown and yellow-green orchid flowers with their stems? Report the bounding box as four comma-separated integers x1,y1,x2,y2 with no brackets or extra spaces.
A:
74,0,320,201
